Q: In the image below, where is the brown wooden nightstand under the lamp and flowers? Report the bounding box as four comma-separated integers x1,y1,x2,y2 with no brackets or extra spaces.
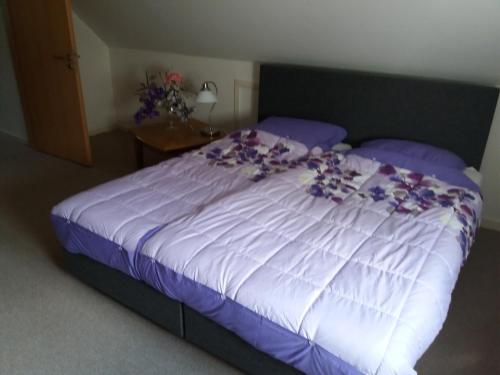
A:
130,119,225,169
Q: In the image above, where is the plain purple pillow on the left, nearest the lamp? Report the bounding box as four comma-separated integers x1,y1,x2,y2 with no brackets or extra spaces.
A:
255,117,347,150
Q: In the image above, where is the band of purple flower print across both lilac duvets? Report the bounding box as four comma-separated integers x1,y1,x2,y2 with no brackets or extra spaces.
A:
204,140,479,261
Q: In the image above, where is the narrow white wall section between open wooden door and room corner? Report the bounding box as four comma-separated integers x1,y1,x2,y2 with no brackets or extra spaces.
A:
73,13,116,135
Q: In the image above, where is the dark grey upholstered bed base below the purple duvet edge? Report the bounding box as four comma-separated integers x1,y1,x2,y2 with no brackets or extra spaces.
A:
63,251,301,375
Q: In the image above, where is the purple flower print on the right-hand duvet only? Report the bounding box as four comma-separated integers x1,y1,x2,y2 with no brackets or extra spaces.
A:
305,156,479,261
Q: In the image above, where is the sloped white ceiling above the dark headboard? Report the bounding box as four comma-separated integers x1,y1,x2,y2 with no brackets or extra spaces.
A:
73,0,500,84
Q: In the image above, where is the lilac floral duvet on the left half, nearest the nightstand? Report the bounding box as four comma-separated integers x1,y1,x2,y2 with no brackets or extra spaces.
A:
51,130,308,279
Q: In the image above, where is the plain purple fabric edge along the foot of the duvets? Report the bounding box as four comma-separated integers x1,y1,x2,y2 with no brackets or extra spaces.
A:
51,214,362,375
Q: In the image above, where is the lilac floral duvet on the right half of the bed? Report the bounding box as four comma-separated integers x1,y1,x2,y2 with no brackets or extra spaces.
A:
137,153,482,375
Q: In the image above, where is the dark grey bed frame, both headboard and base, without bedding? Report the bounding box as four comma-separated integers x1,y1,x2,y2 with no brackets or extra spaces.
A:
64,64,499,375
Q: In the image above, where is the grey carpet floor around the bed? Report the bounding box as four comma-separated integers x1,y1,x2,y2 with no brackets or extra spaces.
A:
0,131,500,375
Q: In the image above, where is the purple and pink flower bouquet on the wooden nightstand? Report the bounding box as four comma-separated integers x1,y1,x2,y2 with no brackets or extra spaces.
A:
134,71,194,124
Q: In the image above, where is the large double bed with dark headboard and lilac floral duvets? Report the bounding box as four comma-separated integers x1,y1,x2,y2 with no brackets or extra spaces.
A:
52,64,498,374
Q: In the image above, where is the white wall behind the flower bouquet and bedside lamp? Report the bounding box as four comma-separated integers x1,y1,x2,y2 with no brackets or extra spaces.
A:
111,48,258,130
